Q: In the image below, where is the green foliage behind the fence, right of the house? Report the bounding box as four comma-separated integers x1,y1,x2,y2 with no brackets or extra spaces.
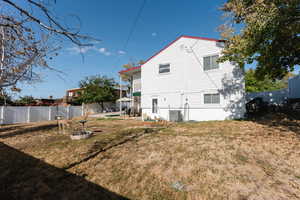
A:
245,69,294,92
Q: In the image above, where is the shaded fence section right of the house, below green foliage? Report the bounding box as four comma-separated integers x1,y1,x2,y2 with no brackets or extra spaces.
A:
246,89,289,105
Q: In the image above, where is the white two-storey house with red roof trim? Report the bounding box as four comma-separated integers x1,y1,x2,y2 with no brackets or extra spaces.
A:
119,36,245,121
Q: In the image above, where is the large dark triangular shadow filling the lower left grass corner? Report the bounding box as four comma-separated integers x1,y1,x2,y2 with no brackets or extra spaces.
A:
0,143,127,200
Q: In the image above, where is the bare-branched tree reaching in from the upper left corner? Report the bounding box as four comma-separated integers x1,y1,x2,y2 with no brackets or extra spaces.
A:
0,0,99,89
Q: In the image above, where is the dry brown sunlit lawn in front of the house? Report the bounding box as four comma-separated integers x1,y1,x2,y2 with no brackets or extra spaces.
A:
0,116,300,200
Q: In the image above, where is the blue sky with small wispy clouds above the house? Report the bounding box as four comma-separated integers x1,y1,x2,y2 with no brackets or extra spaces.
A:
20,0,240,97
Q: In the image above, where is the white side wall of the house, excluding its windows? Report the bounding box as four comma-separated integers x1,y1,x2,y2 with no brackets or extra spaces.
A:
141,38,245,121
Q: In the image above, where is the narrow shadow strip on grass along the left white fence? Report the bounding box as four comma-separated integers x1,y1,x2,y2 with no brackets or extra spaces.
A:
0,124,57,139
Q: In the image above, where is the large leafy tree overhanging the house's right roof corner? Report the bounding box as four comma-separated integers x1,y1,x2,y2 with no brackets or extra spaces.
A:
220,0,300,80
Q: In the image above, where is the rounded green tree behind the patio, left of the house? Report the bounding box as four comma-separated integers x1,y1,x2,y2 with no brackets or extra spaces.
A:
78,75,118,110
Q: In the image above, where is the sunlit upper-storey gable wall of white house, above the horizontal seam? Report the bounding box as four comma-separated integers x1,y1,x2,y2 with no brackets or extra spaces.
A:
141,37,230,92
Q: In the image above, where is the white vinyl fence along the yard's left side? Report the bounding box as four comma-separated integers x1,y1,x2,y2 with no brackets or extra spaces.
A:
0,106,84,124
